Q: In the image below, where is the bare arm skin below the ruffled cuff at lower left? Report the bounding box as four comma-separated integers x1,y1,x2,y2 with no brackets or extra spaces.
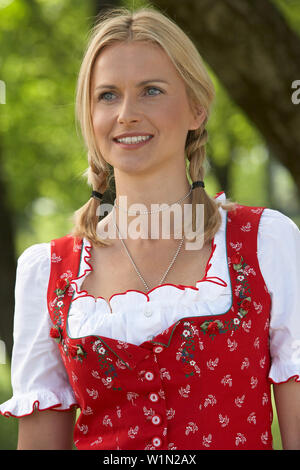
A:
17,408,76,450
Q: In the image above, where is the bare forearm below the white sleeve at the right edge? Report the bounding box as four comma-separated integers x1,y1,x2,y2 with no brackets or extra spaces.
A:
273,380,300,450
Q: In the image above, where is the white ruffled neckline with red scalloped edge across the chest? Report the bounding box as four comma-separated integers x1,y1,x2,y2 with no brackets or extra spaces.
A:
67,194,232,344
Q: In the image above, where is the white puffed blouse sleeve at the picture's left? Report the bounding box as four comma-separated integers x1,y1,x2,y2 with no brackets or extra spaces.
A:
0,243,78,418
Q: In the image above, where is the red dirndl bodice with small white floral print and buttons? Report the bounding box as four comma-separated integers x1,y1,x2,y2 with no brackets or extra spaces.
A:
48,205,272,450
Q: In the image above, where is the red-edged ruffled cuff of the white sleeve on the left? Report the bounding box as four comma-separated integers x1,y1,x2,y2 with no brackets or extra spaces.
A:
0,390,79,418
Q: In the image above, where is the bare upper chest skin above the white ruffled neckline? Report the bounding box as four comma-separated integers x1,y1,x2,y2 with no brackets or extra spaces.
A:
81,240,212,308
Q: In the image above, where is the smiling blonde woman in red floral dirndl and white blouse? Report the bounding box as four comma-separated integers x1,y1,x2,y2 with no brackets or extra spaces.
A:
1,8,300,450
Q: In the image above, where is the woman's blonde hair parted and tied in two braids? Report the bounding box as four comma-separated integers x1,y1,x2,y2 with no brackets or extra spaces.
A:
71,6,236,246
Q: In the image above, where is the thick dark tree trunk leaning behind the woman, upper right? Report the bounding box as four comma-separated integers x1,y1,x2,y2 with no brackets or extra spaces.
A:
154,0,300,194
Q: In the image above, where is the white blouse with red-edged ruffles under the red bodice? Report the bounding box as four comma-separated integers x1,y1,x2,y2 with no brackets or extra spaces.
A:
0,192,300,417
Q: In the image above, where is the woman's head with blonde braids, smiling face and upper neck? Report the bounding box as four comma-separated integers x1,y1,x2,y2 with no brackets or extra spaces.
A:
72,8,235,247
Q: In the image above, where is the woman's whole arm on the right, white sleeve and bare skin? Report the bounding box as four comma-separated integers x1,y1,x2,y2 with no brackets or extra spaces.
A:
257,209,300,449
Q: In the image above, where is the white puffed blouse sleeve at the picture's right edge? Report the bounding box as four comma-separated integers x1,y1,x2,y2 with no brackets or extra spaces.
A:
257,209,300,383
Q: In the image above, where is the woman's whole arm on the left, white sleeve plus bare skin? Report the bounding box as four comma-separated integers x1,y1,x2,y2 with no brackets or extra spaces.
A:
0,243,77,450
